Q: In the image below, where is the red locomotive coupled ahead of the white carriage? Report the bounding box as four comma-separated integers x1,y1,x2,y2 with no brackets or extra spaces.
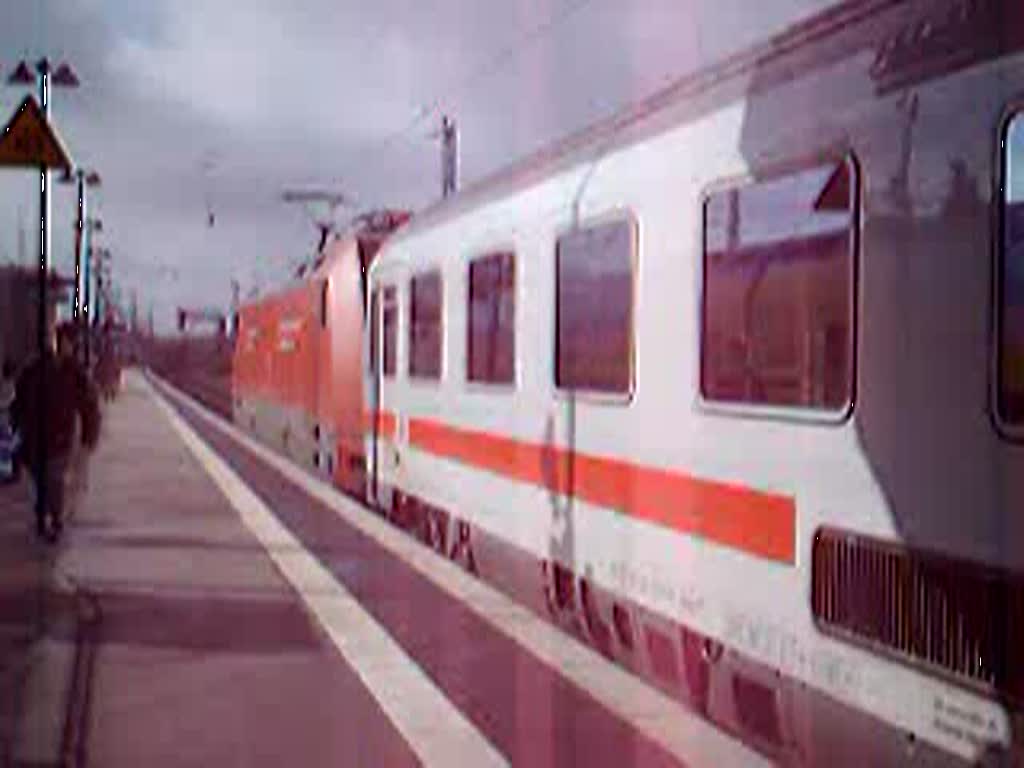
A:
231,211,410,495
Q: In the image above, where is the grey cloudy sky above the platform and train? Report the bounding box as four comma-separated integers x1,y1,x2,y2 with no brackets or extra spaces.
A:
0,0,834,328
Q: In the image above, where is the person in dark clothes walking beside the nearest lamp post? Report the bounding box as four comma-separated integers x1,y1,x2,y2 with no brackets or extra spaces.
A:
13,325,99,542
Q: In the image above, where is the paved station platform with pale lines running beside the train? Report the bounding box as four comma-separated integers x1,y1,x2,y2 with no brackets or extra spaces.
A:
0,372,762,766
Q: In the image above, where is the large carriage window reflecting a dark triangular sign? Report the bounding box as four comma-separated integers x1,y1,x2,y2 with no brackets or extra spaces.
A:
700,157,857,411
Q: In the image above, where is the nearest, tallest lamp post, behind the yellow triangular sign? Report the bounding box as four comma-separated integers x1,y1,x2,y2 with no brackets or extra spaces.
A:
7,57,79,536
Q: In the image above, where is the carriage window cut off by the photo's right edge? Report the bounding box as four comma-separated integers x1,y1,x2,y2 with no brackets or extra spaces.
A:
998,114,1024,427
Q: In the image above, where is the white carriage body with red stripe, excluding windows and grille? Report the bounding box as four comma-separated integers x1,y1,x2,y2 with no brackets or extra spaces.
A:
367,3,1024,762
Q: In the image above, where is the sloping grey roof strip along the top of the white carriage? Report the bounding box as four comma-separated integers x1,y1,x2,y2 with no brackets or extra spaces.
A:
392,0,1011,242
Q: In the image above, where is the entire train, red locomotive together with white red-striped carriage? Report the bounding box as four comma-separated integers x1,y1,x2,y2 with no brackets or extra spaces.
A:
233,0,1024,765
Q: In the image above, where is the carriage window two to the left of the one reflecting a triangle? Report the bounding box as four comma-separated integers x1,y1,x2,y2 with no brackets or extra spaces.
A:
466,252,515,384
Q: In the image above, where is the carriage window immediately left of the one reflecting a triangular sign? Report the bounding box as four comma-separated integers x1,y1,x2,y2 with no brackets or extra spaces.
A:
555,220,634,394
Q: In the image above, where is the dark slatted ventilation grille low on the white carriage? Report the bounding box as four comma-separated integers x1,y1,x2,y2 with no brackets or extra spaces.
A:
811,529,1024,701
